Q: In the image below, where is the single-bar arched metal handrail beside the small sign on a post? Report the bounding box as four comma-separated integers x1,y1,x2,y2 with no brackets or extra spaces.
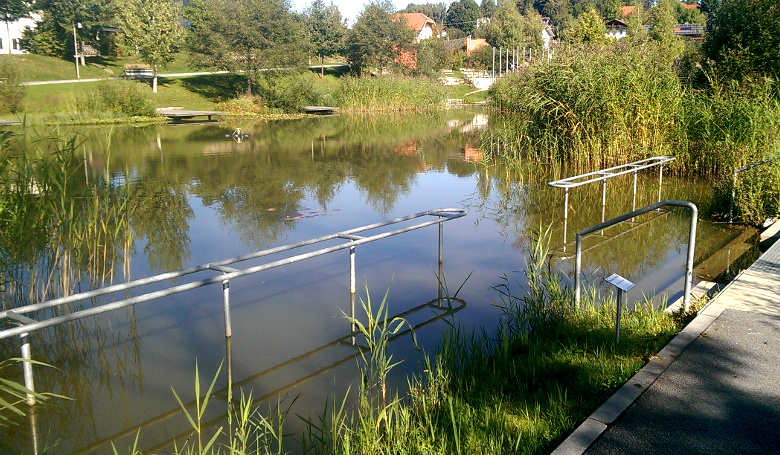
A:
574,199,699,311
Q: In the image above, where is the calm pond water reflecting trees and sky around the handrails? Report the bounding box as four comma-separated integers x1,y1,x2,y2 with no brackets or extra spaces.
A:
0,108,753,454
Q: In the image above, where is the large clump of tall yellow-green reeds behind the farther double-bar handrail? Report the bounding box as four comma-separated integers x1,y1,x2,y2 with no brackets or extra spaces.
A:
490,40,685,168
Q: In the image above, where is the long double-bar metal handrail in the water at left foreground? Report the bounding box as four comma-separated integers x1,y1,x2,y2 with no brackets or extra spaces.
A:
0,208,468,405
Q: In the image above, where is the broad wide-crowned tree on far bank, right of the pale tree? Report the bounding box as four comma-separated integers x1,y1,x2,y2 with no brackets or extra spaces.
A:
187,0,309,95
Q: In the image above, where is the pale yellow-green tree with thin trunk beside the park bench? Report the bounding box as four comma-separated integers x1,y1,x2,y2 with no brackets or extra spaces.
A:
118,0,184,93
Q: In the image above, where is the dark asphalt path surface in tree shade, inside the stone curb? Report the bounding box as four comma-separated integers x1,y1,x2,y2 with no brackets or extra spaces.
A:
585,308,780,455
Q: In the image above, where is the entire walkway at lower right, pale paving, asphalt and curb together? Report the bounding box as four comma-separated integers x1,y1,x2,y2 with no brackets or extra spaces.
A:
553,230,780,455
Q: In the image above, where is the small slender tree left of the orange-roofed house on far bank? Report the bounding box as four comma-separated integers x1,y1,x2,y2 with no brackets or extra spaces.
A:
303,0,347,75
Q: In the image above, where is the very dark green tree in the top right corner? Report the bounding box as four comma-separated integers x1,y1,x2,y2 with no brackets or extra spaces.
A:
702,0,780,80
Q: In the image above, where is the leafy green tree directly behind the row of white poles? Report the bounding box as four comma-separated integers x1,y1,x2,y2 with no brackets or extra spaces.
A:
485,0,542,48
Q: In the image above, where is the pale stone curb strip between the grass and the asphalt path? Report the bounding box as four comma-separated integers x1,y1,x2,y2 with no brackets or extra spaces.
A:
552,303,724,455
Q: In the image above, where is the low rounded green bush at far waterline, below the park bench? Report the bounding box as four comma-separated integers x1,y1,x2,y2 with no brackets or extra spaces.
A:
71,81,156,118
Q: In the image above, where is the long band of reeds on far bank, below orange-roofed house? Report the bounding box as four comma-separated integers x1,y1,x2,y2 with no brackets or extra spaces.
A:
334,76,446,111
